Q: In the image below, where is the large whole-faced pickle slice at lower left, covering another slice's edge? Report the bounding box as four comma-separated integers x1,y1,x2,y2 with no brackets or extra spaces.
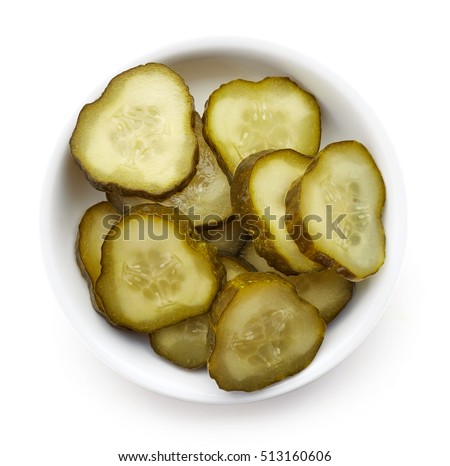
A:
95,204,225,333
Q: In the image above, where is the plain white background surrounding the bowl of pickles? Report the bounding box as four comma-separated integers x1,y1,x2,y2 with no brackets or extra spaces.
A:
0,0,450,466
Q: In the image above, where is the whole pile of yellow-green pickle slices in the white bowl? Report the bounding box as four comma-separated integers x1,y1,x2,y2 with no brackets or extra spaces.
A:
70,59,386,392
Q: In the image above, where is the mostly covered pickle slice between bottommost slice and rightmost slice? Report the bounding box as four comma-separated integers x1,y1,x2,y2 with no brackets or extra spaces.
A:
285,269,355,323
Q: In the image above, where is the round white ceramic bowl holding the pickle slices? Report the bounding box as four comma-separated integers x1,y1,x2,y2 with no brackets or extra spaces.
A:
41,38,406,403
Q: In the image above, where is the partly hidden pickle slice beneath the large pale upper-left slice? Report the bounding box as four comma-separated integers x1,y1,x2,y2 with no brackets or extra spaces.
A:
107,113,232,227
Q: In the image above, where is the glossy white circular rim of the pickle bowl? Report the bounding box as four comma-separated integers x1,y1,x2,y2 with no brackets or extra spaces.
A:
39,36,407,404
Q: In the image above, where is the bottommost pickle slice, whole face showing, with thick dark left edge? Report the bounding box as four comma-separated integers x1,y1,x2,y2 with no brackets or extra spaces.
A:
208,272,326,392
